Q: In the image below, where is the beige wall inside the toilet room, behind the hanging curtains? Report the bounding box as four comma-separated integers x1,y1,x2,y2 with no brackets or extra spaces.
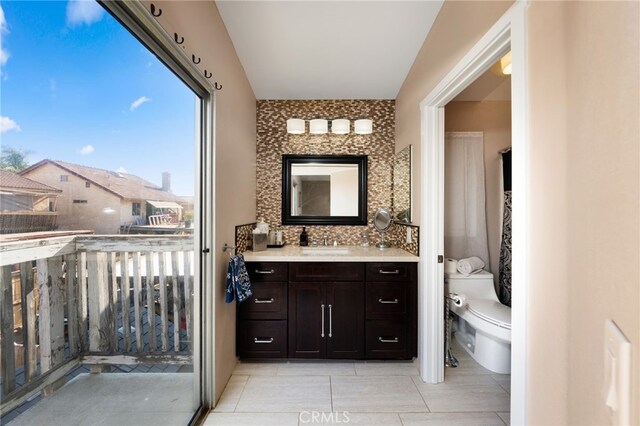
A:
444,101,511,283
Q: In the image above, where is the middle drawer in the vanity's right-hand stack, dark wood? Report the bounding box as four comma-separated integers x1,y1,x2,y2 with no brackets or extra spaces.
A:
365,282,409,319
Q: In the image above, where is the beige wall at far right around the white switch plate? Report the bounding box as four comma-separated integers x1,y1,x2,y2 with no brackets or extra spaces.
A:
564,1,640,425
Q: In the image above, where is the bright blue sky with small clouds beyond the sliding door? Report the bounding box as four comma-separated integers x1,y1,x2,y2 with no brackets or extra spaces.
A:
0,0,195,195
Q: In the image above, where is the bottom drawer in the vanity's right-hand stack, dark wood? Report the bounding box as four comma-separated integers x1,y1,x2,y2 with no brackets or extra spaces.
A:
365,320,411,359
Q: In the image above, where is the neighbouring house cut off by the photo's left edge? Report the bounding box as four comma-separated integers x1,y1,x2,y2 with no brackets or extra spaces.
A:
0,170,62,234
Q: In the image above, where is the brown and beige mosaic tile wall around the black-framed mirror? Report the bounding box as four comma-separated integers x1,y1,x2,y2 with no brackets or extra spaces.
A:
256,100,417,254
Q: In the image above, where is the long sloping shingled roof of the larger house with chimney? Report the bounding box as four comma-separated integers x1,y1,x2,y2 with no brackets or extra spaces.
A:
21,159,184,203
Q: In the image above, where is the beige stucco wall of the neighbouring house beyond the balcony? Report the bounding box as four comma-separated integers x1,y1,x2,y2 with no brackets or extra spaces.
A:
25,163,120,234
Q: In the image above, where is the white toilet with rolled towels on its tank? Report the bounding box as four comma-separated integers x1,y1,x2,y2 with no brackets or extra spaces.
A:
444,271,511,374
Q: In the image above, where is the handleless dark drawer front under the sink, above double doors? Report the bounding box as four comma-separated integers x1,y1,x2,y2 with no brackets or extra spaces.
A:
289,262,364,282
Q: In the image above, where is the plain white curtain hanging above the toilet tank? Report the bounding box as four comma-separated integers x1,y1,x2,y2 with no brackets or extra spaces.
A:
444,132,490,270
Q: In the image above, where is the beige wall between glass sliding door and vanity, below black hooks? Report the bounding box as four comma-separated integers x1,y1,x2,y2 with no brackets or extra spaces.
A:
151,1,256,398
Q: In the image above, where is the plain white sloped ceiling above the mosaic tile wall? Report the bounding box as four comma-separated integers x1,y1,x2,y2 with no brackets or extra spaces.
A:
216,0,443,99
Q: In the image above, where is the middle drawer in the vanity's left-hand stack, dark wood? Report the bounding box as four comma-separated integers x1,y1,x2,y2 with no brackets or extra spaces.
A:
238,282,287,319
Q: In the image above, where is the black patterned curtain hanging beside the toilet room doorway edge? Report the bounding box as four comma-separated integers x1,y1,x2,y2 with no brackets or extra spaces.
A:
498,149,511,306
